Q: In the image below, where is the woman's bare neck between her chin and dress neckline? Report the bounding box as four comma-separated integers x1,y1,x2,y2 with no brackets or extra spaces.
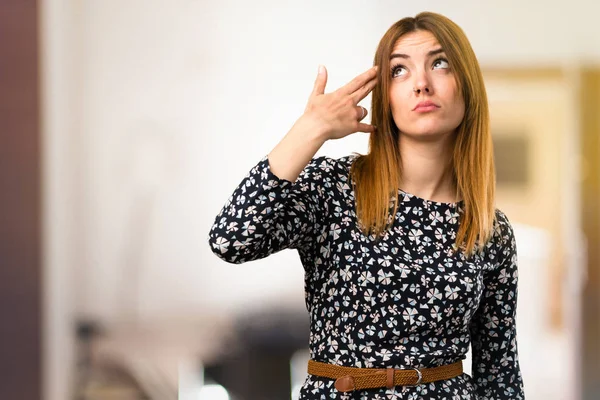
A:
399,134,460,203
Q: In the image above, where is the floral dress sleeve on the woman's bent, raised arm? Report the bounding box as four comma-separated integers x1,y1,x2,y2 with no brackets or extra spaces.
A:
208,156,332,264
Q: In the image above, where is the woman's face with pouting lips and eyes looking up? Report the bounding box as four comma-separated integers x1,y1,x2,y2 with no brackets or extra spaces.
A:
389,30,465,140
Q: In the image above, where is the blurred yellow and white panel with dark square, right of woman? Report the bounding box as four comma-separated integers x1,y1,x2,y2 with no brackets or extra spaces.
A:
484,67,586,399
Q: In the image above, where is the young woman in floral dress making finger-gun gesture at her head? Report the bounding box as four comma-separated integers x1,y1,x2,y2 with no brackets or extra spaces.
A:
209,12,524,400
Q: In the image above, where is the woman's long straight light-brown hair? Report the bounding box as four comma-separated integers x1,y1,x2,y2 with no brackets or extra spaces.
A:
351,12,496,256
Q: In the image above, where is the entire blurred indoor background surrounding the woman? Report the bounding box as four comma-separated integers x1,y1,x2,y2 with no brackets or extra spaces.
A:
0,0,600,400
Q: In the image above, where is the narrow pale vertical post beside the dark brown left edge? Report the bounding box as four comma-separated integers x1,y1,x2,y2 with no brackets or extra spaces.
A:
38,0,81,400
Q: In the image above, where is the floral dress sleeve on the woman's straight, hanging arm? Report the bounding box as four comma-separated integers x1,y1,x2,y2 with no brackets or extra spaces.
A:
470,211,525,400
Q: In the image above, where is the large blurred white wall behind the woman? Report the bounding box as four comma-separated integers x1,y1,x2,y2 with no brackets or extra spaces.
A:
42,0,600,399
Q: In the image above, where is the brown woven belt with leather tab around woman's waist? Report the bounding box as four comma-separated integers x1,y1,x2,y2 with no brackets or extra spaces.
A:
308,360,463,392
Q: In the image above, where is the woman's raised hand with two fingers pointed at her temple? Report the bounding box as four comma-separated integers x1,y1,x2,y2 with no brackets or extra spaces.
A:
303,66,377,140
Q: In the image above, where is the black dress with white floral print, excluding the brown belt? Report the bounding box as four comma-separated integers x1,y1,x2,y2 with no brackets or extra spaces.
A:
208,154,524,400
